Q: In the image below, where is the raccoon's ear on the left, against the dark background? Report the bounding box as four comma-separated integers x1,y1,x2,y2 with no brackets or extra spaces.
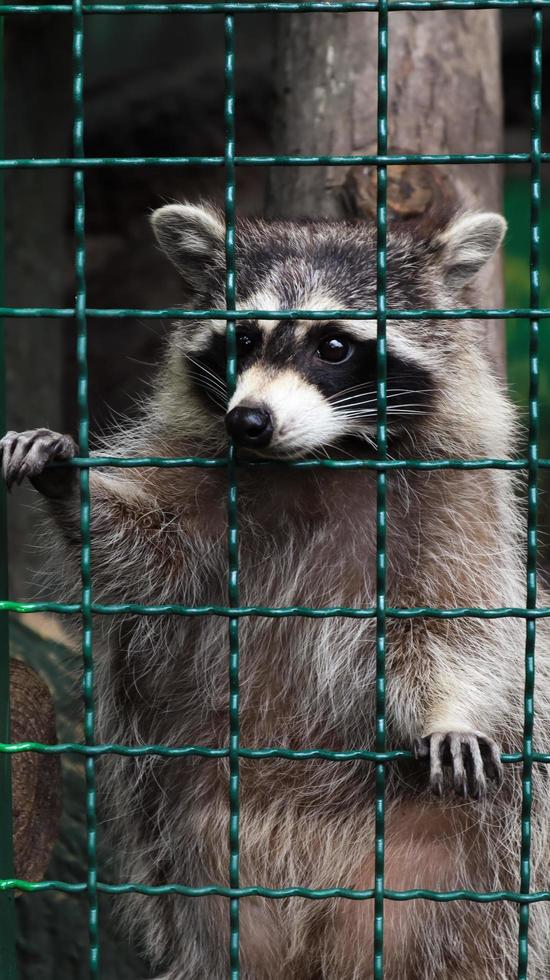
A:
151,204,225,294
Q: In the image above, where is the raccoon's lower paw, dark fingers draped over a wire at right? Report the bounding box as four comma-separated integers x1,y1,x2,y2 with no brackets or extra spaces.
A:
414,732,502,800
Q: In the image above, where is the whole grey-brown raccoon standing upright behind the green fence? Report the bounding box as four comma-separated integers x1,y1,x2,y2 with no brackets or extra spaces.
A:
1,204,550,980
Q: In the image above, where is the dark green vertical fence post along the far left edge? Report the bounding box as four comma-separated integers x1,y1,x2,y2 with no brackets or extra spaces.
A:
0,0,17,980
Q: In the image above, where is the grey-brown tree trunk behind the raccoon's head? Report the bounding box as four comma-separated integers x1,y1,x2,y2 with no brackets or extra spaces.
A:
268,10,505,374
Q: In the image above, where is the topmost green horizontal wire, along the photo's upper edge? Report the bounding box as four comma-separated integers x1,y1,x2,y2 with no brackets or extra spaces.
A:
2,0,550,14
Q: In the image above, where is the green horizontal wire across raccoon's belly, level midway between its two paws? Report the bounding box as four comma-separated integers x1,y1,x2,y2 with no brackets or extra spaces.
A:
0,599,550,619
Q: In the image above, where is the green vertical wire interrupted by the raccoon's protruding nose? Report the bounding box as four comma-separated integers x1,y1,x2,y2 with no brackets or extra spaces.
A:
224,14,240,980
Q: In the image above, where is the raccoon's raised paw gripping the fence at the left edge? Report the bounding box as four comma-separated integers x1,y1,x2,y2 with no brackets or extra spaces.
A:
0,429,77,498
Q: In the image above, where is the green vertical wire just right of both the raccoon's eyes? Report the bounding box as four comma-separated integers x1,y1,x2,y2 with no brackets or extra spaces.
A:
373,0,388,980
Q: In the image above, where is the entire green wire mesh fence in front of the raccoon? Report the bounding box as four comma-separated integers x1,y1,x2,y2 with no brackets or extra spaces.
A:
0,0,550,980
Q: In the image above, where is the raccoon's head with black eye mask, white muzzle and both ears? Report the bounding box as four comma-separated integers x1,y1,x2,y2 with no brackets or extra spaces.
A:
152,205,505,458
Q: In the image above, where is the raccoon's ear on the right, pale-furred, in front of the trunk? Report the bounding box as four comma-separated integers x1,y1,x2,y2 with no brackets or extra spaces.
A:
435,212,506,287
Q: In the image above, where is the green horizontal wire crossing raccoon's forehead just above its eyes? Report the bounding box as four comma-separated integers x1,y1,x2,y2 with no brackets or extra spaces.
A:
0,306,550,320
